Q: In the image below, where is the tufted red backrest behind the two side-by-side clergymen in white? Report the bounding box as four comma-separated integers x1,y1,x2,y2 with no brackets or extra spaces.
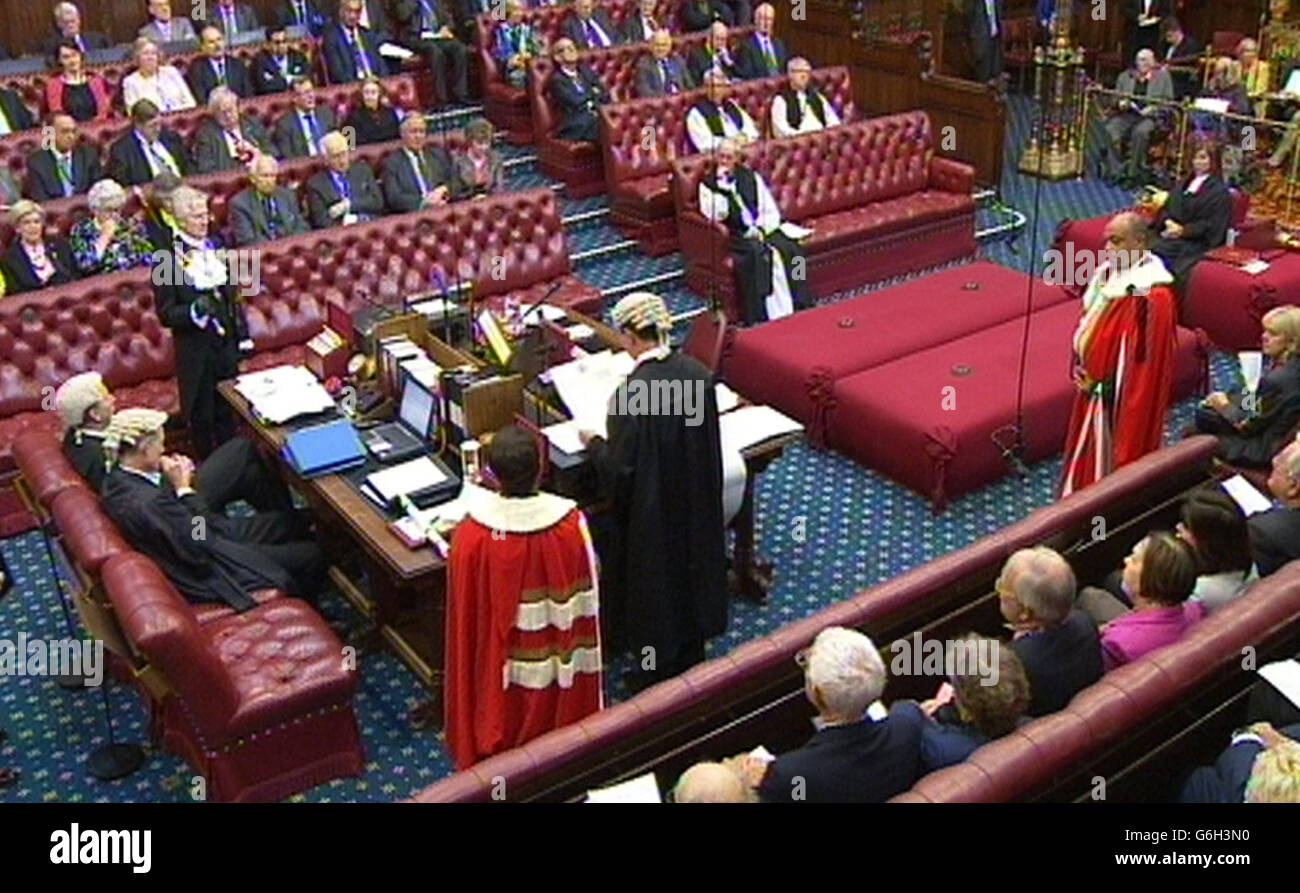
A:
599,66,854,191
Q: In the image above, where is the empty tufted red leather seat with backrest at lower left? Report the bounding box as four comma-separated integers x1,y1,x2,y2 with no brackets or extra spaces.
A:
103,552,364,802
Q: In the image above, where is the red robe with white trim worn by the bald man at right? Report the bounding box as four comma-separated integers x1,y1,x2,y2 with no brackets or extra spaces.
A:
1061,272,1178,497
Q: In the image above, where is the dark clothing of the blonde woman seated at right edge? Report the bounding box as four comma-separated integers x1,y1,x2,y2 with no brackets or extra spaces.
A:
1196,359,1300,468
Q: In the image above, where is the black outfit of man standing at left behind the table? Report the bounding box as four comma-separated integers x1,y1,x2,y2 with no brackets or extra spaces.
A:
153,235,248,458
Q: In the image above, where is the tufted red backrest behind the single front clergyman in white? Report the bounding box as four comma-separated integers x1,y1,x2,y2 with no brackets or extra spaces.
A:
673,112,935,227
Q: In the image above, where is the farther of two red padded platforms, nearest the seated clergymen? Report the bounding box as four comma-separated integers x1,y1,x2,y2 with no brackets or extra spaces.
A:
723,261,1067,442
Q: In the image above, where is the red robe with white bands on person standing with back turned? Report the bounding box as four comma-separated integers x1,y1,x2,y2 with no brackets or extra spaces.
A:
443,493,603,770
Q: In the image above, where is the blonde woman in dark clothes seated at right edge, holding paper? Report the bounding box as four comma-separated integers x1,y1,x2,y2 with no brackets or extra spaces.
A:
1196,304,1300,468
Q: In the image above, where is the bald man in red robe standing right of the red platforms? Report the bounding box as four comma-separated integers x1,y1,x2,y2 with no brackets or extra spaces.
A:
1061,213,1178,497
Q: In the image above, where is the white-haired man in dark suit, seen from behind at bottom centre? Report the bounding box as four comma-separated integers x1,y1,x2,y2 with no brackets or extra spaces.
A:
742,627,928,803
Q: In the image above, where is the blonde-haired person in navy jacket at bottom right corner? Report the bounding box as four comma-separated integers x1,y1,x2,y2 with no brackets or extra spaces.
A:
1178,723,1300,803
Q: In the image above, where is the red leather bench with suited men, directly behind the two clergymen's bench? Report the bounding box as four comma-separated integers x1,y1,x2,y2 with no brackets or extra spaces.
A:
528,27,754,199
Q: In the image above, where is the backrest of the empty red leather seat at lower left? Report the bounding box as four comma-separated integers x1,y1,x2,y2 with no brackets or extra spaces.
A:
101,552,238,729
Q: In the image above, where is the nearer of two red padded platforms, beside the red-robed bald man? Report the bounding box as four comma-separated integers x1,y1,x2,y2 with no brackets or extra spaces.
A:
828,302,1203,508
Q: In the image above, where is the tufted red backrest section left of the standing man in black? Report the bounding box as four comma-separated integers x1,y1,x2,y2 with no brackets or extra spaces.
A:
0,269,173,417
